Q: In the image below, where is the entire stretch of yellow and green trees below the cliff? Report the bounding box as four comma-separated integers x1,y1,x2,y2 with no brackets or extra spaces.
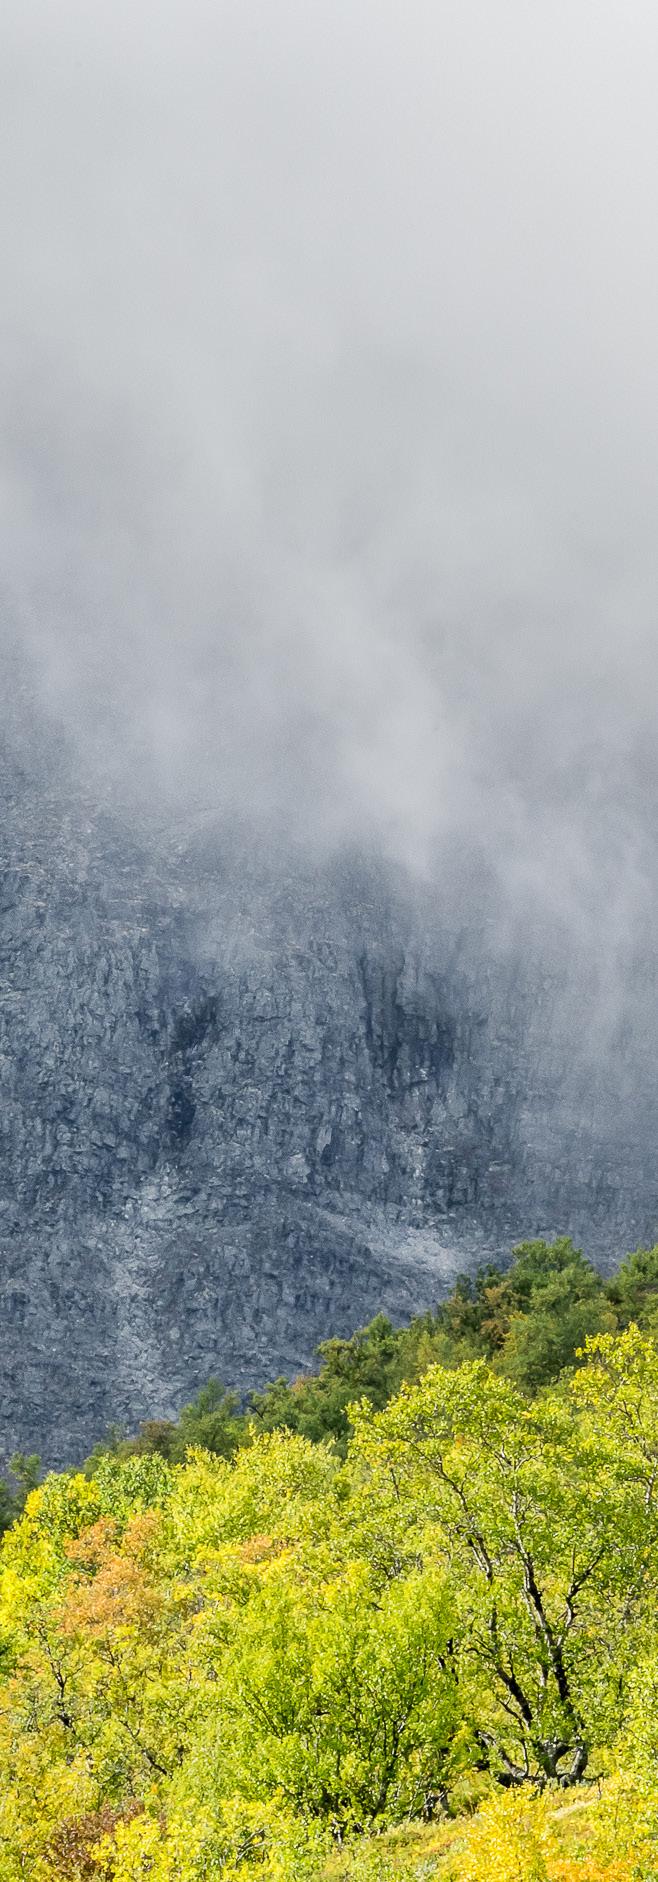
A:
0,1238,658,1882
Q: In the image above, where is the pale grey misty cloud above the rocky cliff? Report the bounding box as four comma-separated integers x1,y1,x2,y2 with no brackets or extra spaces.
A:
0,0,658,920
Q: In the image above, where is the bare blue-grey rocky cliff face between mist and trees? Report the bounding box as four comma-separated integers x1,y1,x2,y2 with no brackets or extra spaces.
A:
0,741,658,1462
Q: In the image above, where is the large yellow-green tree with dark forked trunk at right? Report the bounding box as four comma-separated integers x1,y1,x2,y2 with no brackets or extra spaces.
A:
353,1355,658,1786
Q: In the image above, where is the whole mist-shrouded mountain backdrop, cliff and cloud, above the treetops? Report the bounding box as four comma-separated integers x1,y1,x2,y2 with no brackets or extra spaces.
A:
0,0,658,1457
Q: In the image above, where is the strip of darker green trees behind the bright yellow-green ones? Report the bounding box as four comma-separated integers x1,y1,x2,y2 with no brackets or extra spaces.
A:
90,1236,646,1468
